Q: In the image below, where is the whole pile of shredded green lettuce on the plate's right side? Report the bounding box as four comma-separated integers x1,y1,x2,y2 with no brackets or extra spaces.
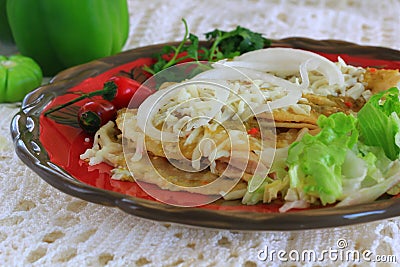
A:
243,88,400,212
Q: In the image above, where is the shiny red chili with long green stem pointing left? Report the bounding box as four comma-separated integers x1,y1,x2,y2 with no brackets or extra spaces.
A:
44,76,155,116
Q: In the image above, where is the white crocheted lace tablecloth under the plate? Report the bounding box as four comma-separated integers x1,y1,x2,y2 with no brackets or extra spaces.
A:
0,0,400,267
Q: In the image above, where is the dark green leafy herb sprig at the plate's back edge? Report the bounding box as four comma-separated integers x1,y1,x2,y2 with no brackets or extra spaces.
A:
144,19,271,75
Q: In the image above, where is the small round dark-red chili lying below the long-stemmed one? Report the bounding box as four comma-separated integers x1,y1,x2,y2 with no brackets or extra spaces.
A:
77,99,117,133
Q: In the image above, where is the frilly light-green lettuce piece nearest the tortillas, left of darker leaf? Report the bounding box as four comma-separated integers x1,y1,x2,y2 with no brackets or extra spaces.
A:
286,113,358,205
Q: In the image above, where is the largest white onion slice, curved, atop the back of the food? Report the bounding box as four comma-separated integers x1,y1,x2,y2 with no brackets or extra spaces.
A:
230,47,344,86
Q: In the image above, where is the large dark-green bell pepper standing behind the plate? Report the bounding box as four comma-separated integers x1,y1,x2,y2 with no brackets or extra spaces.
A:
7,0,129,75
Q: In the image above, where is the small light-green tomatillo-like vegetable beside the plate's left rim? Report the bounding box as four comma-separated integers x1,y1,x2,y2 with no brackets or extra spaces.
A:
0,55,43,103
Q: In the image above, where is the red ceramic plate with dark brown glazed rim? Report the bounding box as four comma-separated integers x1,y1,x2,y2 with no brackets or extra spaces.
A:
11,38,400,230
